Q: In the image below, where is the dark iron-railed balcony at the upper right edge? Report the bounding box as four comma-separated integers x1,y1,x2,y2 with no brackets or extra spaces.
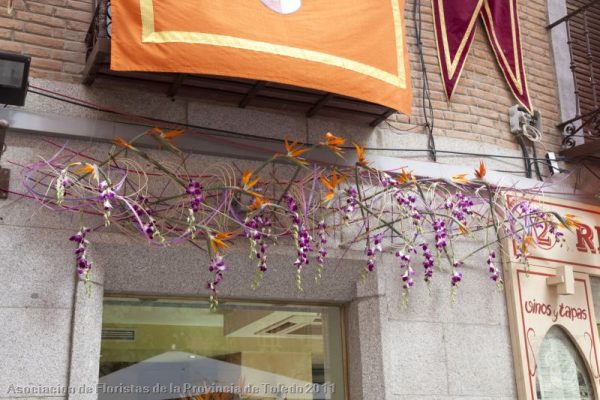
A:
547,0,600,156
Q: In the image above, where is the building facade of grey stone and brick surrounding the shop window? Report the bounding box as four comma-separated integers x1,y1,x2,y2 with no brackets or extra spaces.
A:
0,0,600,400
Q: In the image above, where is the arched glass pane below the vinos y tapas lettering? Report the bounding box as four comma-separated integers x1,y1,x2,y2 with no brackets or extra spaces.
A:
536,326,595,400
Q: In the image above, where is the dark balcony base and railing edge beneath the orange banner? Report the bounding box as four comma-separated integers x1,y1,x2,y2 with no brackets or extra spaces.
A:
84,0,395,126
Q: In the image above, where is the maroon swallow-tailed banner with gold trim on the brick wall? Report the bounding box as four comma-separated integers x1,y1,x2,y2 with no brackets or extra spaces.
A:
432,0,532,111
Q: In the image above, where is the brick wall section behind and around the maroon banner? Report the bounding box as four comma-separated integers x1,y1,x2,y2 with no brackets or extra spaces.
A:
393,0,561,151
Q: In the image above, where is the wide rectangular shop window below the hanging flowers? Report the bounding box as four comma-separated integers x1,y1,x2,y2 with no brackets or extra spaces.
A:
99,297,345,400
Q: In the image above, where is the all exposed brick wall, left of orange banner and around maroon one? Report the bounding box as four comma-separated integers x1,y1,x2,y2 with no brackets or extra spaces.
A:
0,0,560,150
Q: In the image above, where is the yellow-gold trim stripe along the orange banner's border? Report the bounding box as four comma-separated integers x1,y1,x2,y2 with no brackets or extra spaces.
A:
140,0,406,89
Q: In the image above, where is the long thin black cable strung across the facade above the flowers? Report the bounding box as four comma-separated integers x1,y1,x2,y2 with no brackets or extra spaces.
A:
28,87,563,161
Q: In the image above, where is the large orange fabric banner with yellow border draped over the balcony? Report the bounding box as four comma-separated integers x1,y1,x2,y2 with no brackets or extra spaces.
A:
111,0,412,114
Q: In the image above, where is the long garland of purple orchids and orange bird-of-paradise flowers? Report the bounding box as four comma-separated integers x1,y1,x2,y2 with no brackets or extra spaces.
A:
23,128,578,308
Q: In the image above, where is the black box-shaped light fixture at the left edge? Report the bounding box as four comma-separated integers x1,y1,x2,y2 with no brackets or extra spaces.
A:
0,52,31,106
